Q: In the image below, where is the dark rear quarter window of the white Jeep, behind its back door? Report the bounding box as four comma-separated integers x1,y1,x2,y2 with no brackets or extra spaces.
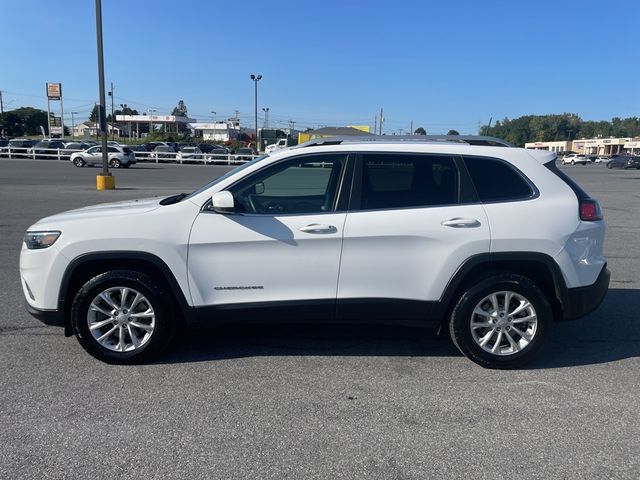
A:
464,157,535,202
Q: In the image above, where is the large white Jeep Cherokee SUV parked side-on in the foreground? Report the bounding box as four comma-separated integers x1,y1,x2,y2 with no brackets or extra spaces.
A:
20,137,609,368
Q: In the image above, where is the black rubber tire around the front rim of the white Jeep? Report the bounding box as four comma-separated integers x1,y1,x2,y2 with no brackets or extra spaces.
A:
71,270,177,364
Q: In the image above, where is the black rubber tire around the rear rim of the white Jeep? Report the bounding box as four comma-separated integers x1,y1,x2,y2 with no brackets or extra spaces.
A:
449,273,553,369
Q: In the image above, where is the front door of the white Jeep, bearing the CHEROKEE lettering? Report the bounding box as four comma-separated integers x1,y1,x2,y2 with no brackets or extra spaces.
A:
188,154,349,317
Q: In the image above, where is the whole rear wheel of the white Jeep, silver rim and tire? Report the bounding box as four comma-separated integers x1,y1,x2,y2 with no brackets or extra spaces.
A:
449,274,553,369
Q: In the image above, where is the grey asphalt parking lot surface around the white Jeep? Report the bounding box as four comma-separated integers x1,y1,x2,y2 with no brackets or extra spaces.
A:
0,159,640,479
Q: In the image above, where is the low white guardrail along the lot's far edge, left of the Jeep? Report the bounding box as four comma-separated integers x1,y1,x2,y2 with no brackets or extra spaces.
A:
0,147,258,165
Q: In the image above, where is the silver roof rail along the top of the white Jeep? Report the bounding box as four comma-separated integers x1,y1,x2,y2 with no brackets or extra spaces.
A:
292,135,513,148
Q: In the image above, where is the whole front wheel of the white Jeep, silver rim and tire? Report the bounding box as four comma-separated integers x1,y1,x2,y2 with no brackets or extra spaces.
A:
71,270,176,364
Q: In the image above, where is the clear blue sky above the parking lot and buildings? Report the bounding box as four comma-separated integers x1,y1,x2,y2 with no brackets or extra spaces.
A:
0,0,640,134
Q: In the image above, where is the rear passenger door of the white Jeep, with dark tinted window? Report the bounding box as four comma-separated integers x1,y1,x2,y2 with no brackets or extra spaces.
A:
338,153,490,320
